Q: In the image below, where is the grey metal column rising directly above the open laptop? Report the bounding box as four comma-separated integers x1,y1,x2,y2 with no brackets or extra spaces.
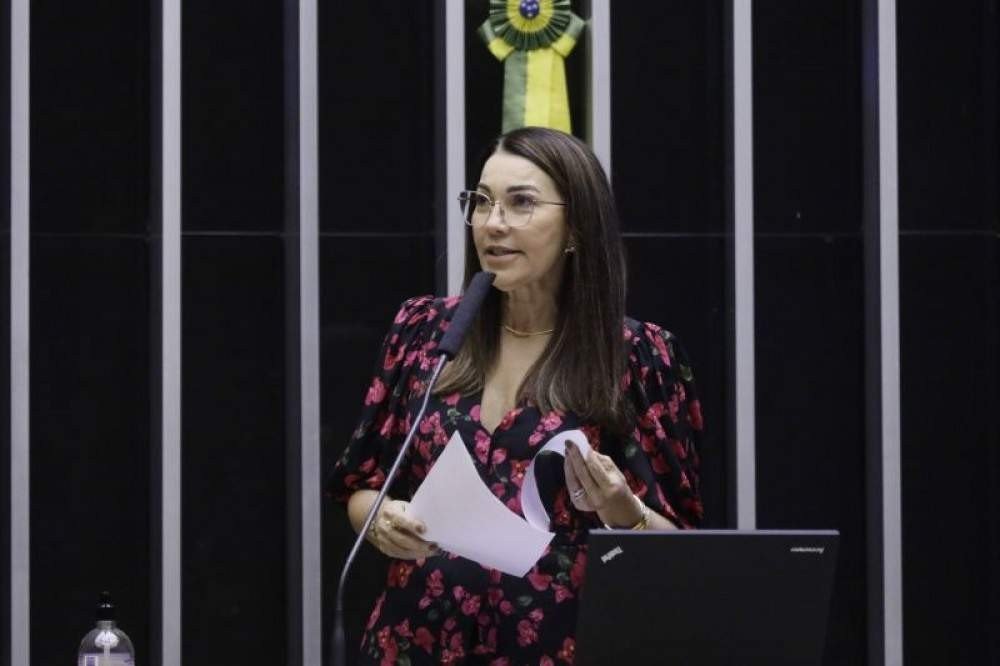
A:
726,0,757,530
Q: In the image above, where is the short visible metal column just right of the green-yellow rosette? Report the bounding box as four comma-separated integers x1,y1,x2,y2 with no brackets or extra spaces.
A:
586,0,611,174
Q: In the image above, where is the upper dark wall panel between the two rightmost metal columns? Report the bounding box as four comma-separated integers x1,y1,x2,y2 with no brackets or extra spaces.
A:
753,0,861,233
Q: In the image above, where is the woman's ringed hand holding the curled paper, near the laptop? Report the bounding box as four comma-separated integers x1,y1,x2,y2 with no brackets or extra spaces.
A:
564,442,643,528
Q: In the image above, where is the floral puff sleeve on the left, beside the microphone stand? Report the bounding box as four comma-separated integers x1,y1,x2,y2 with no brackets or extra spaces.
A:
326,296,440,501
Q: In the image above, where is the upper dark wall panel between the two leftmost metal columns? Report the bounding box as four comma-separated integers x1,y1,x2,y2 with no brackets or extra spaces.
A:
31,0,150,233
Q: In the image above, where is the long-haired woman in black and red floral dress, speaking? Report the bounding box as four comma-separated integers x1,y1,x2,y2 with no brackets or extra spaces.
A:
331,128,702,665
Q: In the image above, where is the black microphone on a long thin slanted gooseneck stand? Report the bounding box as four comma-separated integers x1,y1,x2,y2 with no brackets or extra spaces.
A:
330,271,496,666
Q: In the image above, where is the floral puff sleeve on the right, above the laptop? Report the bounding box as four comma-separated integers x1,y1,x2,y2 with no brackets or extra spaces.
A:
622,322,704,528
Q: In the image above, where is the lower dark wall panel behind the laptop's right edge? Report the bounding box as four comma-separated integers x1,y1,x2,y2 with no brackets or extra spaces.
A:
755,236,867,666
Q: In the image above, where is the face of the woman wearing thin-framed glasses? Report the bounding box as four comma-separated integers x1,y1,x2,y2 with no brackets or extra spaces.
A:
472,151,569,294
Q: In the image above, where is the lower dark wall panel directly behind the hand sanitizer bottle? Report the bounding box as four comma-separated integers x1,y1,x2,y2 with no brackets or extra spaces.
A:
31,236,151,665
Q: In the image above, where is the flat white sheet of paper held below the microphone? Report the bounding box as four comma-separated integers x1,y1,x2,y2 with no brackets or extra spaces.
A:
407,432,553,576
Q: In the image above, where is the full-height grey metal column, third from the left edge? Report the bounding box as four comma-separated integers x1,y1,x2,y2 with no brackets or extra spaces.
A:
298,0,323,665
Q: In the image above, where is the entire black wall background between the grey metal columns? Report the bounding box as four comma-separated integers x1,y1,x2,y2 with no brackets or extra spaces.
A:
0,0,1000,666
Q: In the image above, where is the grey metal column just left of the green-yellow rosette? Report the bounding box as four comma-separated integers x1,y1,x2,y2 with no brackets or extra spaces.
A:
444,0,468,294
